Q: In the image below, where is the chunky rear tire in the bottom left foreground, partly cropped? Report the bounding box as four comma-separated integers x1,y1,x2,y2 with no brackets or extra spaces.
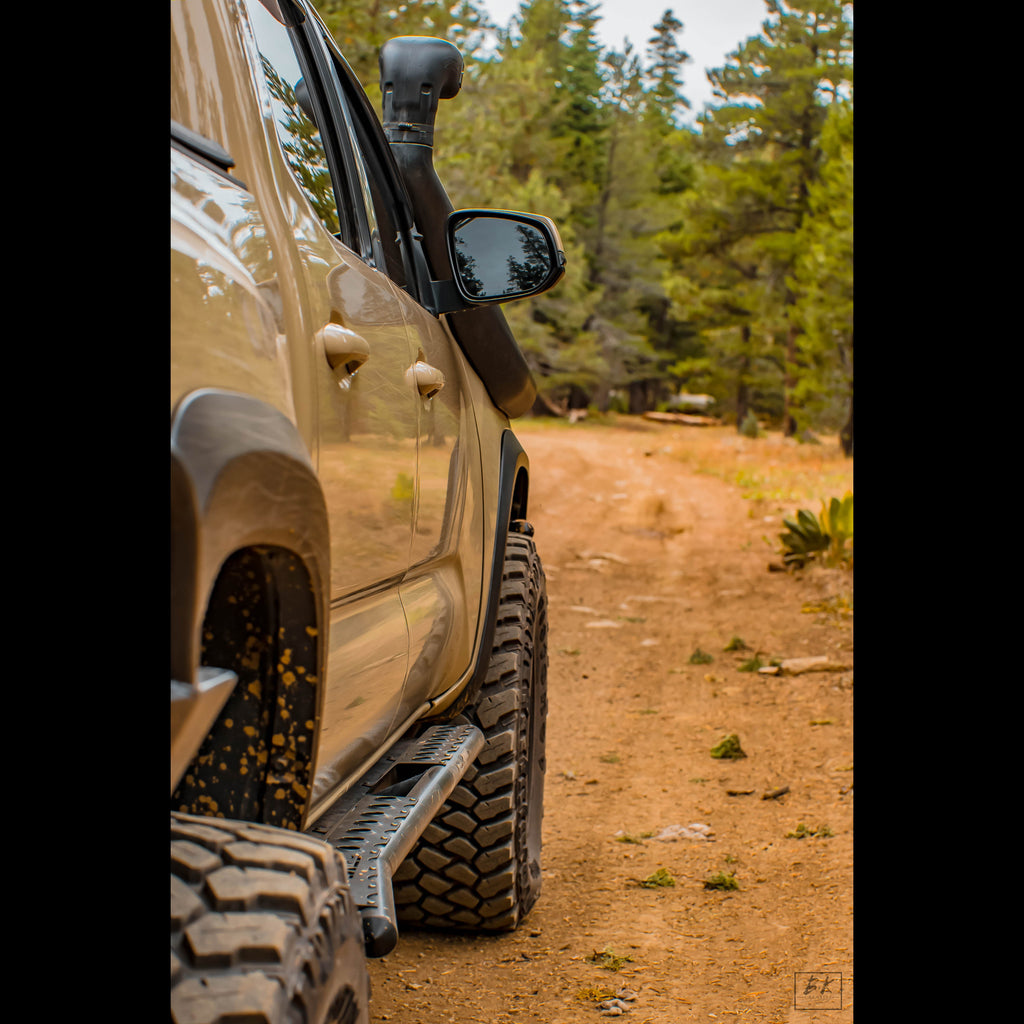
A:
171,813,370,1024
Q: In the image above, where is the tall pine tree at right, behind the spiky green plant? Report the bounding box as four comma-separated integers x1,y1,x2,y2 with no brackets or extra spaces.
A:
666,0,852,433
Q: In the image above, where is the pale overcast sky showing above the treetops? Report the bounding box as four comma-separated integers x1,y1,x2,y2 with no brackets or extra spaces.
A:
480,0,768,122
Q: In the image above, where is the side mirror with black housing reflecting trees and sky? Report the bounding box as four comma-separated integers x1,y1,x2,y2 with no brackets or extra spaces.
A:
446,210,565,306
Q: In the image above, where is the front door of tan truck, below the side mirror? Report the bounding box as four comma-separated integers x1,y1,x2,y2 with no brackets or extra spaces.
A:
309,18,483,719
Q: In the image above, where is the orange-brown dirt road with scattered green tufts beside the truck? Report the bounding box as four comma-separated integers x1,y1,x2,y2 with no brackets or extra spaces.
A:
371,418,853,1024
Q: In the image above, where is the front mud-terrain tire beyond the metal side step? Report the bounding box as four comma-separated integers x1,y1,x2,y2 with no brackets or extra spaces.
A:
393,534,548,931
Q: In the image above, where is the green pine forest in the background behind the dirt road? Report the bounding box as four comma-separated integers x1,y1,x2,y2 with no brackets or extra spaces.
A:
316,0,853,455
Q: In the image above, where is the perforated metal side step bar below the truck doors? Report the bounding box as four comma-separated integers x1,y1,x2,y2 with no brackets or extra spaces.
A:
306,725,483,956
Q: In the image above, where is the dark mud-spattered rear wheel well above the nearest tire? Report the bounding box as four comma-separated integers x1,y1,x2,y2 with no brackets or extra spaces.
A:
171,546,323,829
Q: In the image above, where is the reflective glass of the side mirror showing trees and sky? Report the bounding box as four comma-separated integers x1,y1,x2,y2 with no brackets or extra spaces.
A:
454,217,552,299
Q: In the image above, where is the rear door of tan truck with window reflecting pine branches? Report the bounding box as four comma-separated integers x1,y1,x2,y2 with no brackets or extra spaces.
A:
246,0,420,817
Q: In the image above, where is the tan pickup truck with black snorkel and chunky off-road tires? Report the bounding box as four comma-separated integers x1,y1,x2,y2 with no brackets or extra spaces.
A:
170,0,565,1024
